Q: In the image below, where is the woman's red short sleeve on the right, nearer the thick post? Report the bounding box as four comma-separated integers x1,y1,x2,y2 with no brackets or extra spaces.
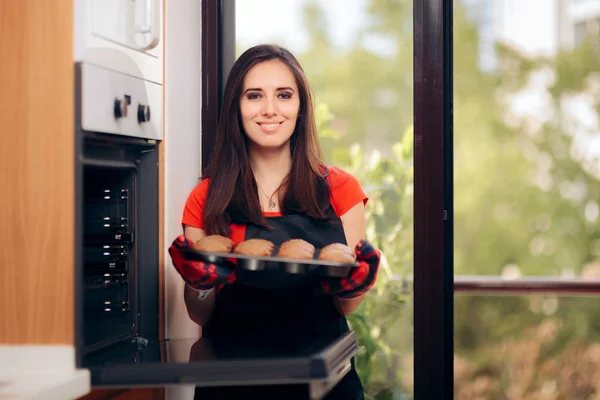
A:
327,167,369,217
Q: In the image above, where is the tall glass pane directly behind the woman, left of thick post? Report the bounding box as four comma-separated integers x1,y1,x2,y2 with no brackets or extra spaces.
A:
236,0,413,399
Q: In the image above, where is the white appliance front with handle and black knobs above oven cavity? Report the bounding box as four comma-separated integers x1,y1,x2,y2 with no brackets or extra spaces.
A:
74,0,163,140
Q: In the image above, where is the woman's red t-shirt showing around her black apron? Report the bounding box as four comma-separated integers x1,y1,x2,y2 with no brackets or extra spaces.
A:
181,167,368,244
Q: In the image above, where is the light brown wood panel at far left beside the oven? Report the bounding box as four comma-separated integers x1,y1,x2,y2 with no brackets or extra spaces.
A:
0,0,75,345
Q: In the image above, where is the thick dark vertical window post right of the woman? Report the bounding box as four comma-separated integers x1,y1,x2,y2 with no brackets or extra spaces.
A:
413,0,454,399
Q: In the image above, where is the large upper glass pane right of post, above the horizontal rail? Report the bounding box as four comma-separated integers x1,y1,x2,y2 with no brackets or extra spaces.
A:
454,0,600,277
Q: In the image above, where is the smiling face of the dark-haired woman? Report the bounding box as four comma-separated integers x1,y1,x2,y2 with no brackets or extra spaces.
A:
240,60,300,149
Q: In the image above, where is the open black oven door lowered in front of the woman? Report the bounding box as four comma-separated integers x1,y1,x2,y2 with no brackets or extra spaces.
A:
84,331,361,387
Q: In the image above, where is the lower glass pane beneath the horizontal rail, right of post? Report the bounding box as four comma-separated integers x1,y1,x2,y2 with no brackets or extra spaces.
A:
454,295,600,399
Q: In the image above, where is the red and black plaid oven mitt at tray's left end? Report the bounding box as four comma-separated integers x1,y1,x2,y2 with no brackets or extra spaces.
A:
169,235,236,290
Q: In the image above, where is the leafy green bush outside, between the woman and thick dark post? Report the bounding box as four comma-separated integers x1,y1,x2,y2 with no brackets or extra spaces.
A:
316,104,413,399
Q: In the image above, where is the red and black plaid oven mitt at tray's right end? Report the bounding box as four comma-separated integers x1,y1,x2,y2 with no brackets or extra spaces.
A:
321,240,381,299
